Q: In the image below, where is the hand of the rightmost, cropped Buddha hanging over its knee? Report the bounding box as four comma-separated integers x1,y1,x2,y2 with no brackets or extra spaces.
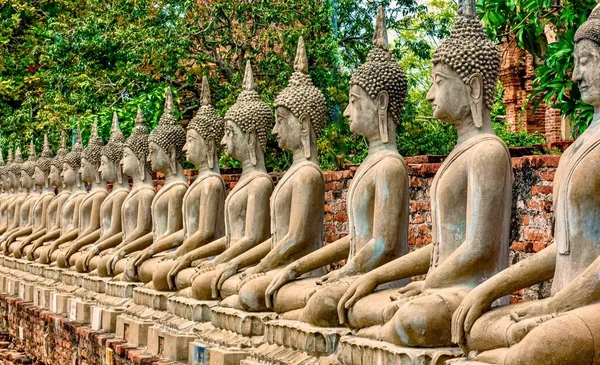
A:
452,285,495,346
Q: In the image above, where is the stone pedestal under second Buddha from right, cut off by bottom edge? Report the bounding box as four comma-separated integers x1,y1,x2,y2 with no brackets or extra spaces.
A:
337,336,462,365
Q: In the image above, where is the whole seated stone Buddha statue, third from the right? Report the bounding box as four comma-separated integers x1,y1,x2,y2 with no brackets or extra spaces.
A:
266,12,409,326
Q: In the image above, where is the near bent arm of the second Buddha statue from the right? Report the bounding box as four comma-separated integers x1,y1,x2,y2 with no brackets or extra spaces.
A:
425,144,511,288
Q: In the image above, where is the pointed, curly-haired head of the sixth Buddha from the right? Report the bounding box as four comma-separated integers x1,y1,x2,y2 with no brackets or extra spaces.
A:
183,76,225,169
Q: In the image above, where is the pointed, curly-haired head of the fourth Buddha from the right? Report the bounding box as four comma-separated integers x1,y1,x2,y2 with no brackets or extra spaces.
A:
272,37,328,158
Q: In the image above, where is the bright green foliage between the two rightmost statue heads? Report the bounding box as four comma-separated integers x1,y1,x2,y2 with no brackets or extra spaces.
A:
478,0,597,134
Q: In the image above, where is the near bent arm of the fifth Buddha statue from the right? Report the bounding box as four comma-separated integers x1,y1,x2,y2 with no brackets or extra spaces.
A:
212,179,273,264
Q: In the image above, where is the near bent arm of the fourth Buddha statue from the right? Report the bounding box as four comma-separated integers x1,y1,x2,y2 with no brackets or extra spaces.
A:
255,169,324,273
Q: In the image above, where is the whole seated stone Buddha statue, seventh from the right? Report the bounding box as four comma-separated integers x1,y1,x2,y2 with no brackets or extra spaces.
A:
122,88,188,283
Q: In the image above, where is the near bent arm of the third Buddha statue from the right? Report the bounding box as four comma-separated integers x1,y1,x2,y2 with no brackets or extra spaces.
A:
340,161,408,276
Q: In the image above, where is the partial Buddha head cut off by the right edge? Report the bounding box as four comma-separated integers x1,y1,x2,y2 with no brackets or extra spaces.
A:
573,5,600,107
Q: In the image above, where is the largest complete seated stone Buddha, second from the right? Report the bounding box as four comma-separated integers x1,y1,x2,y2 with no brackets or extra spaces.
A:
338,0,512,347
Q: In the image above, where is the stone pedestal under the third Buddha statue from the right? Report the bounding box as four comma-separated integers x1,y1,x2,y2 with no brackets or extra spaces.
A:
249,320,351,364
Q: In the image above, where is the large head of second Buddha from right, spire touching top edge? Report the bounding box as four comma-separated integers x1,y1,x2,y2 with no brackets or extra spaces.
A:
427,0,500,128
